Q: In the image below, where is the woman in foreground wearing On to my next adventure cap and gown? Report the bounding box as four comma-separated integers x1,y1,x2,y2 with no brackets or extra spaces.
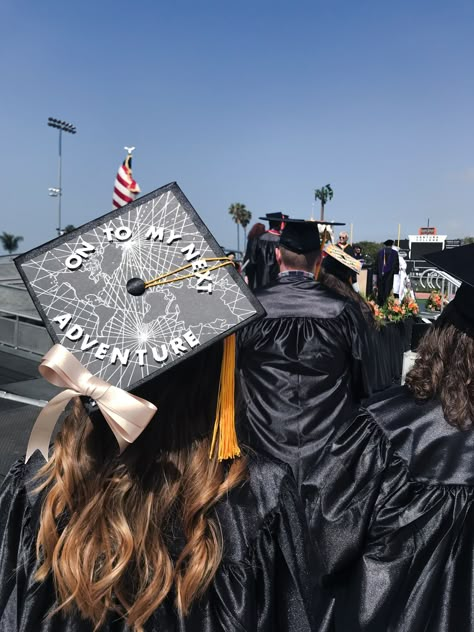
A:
0,183,317,632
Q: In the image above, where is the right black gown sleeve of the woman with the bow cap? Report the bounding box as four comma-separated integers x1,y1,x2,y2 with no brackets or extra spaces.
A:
252,476,317,632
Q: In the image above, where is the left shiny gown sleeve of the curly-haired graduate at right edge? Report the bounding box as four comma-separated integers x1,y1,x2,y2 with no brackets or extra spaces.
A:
302,411,391,584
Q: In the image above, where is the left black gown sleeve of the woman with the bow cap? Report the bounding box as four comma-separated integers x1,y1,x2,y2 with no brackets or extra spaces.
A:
0,460,35,632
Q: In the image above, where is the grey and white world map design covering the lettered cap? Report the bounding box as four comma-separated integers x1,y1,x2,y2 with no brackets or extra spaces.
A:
22,191,256,388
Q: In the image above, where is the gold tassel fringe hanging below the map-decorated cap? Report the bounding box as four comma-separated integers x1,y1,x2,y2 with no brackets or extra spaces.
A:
209,334,240,461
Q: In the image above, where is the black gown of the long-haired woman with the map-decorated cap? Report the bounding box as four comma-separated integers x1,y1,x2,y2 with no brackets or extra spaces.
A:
0,452,316,632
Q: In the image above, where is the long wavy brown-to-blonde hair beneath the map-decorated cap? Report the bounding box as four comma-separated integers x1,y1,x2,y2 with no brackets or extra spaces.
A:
36,345,247,632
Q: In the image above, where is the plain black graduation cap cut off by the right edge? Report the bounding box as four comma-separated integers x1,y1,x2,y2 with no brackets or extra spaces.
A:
424,244,474,338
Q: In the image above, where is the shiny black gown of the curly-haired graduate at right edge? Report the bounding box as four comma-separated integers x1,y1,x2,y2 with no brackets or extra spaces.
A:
303,387,474,632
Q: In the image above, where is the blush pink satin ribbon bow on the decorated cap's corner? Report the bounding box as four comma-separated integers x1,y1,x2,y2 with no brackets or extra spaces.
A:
26,345,157,461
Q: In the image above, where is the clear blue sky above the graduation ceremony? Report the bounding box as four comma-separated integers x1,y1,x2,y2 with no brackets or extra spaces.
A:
0,0,474,250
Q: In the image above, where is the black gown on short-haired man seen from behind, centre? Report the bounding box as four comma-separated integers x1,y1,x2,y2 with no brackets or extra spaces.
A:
238,274,368,483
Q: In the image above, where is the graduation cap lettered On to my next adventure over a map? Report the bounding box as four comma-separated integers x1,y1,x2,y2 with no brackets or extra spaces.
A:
15,183,264,462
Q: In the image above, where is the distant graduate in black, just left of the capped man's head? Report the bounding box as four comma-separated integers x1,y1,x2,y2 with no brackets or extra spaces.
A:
254,212,288,290
